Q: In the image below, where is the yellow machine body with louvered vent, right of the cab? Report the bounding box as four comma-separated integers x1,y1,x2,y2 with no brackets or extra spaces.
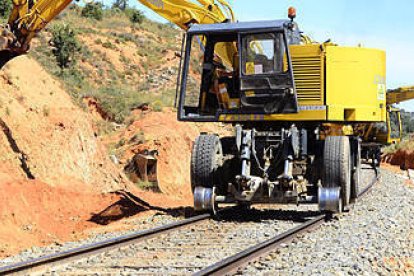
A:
220,44,386,123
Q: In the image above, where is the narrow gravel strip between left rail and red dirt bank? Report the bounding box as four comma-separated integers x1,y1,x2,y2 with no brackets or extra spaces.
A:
0,212,184,267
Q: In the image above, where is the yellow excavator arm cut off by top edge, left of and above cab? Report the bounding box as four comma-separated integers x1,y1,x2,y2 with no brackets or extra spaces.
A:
0,0,235,54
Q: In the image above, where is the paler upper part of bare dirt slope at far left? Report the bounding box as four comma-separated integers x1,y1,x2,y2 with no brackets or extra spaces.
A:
0,56,126,192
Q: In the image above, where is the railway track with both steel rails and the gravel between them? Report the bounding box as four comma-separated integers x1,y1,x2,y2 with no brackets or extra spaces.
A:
0,165,378,275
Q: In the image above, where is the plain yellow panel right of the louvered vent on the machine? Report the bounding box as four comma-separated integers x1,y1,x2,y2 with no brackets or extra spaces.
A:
326,46,386,122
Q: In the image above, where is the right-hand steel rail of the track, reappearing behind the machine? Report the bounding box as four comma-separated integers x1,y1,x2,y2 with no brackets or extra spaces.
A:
193,165,379,276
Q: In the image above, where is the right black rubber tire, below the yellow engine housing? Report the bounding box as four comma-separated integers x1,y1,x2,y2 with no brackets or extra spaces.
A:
322,136,352,209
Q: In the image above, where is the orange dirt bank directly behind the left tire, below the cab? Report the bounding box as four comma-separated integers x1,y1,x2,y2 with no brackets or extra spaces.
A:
118,109,226,201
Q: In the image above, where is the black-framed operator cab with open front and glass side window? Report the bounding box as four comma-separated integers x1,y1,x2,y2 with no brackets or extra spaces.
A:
178,20,300,121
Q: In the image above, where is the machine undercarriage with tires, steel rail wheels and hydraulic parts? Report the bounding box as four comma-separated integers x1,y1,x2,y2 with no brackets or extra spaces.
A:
191,125,368,211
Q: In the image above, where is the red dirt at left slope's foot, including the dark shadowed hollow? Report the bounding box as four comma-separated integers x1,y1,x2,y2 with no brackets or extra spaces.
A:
0,173,185,258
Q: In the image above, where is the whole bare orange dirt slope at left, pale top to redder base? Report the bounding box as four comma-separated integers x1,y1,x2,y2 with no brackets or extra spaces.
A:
0,56,128,257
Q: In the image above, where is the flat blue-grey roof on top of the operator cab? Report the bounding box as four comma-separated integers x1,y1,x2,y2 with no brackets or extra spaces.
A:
188,20,290,34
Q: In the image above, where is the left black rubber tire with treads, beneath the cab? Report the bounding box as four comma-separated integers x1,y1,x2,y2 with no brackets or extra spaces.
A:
191,135,223,192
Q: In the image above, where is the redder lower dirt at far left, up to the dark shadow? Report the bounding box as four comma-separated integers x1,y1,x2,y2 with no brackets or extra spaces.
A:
0,178,120,257
